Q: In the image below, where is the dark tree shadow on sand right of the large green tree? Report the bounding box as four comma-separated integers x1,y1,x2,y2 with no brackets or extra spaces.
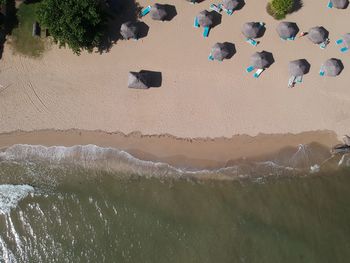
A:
98,0,142,54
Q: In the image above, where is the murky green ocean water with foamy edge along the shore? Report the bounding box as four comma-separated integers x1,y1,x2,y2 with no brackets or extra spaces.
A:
0,145,350,263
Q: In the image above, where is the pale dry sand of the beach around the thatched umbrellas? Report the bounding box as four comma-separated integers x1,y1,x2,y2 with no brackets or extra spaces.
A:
0,0,350,161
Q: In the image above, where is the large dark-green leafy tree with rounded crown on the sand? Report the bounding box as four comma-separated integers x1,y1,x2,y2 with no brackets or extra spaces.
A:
37,0,107,55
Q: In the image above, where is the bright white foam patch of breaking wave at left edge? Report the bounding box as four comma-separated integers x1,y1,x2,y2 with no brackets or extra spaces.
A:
0,184,34,214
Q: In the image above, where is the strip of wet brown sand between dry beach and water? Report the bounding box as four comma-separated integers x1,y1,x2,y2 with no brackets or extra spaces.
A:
0,129,339,169
